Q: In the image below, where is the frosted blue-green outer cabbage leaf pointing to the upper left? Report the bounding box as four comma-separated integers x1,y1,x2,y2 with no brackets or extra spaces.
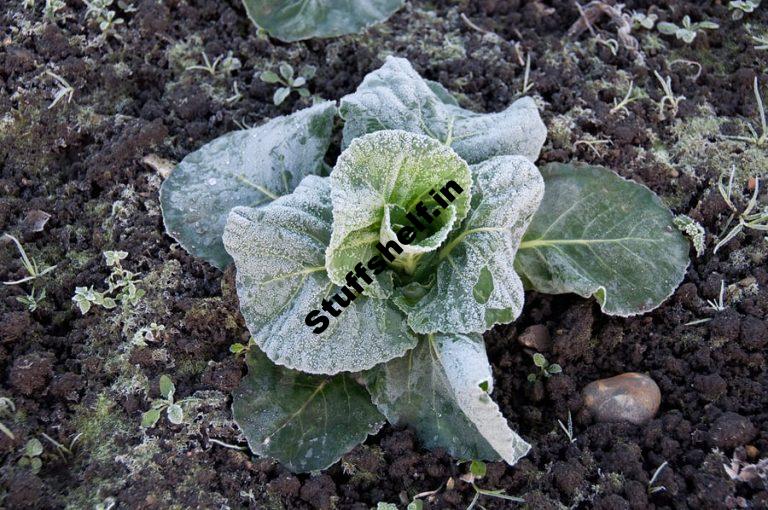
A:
160,101,336,269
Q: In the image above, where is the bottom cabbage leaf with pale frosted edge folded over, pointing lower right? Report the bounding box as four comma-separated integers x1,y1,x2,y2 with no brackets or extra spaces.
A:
366,335,530,464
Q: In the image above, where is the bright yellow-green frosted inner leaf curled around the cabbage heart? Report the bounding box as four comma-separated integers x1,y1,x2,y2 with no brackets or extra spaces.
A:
326,130,472,290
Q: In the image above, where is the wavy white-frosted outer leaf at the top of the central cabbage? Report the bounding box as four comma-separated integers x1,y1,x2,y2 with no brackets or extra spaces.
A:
340,57,547,164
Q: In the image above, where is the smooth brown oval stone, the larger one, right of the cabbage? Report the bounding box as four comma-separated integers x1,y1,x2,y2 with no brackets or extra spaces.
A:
582,372,661,425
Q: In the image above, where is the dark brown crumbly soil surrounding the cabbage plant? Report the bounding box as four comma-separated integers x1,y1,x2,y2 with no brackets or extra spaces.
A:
0,0,768,509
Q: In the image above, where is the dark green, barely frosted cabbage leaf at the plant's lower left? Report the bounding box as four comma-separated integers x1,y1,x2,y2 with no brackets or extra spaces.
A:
232,348,384,471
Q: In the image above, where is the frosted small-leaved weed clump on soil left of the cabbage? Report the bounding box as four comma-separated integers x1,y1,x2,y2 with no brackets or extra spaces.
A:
72,251,146,315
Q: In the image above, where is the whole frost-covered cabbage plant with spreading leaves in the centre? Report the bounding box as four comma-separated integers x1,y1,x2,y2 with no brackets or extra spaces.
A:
161,58,688,471
